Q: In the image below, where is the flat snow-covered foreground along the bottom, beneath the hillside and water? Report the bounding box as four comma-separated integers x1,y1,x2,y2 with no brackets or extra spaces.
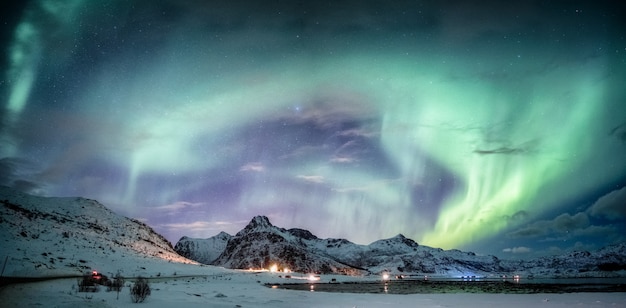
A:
0,273,626,307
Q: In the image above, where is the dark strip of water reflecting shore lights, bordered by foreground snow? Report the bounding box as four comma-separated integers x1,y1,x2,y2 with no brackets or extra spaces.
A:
267,278,626,294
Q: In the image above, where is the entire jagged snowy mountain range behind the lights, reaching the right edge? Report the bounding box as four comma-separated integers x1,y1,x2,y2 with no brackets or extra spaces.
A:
176,216,626,277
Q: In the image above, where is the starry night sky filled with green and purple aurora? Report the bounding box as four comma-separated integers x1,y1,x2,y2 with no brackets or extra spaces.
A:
0,0,626,258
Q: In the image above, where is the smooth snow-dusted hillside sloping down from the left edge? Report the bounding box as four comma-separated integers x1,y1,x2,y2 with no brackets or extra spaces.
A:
0,186,196,277
